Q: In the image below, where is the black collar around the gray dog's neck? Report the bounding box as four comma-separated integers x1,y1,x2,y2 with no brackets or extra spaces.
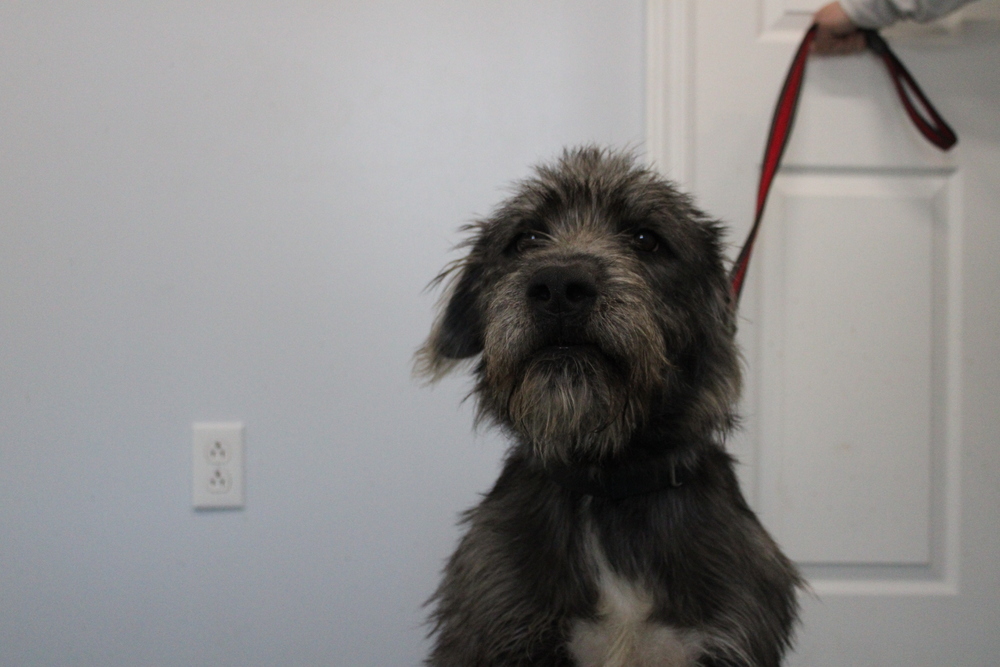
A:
546,460,694,500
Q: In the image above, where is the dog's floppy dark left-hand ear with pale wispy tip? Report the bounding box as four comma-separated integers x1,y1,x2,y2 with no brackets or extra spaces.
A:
414,259,483,382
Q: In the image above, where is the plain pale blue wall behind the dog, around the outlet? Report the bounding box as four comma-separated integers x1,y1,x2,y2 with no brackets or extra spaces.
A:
0,0,643,667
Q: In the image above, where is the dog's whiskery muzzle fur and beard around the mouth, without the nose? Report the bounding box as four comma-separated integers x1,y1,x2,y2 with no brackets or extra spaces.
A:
475,274,672,464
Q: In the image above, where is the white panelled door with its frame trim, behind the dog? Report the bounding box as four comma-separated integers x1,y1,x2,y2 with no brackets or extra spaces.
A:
648,0,1000,667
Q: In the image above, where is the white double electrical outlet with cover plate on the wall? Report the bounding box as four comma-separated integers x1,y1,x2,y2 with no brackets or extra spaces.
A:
191,422,244,509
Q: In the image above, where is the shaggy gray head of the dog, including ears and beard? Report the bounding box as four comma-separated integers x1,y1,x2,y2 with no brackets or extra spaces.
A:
417,148,740,462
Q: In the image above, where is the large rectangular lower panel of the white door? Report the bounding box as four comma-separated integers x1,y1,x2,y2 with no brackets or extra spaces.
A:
757,170,961,588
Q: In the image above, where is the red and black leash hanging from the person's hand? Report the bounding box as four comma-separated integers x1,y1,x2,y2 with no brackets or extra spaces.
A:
729,25,958,307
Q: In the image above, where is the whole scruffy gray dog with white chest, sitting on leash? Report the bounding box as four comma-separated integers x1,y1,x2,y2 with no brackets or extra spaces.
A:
417,147,800,667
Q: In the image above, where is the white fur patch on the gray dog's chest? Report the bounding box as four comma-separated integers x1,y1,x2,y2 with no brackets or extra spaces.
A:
568,540,701,667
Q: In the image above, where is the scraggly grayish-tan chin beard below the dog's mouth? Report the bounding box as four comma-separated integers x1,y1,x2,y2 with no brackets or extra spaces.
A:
506,346,637,463
